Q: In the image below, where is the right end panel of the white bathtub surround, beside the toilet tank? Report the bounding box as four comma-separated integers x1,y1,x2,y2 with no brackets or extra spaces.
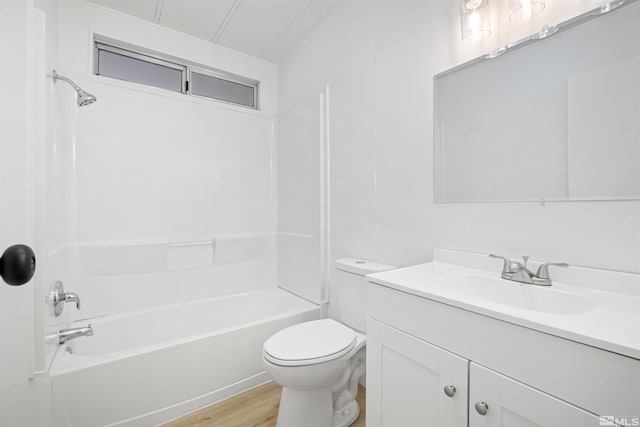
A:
275,87,332,304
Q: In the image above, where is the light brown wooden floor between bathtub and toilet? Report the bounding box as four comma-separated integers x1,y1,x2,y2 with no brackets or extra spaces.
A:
163,382,366,427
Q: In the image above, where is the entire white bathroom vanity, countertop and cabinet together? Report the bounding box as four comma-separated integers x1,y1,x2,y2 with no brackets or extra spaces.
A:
367,249,640,427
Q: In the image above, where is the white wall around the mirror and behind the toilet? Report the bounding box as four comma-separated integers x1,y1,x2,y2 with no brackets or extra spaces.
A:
280,0,640,326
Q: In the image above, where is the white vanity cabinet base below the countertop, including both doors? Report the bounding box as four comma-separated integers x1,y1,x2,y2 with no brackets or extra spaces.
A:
367,283,640,427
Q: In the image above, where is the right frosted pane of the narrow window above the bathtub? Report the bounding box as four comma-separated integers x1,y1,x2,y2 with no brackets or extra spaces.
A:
190,71,256,108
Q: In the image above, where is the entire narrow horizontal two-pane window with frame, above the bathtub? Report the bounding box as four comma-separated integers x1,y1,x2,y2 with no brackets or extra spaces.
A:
93,37,259,110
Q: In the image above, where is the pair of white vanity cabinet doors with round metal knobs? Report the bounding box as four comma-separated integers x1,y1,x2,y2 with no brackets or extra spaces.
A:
367,318,599,427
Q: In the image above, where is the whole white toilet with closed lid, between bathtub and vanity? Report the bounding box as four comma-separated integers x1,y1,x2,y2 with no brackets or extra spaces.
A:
262,258,395,427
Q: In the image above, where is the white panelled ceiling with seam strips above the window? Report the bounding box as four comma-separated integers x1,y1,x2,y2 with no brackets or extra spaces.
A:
89,0,345,63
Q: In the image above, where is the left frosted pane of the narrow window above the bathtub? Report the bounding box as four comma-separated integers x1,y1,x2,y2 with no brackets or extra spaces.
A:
96,49,184,93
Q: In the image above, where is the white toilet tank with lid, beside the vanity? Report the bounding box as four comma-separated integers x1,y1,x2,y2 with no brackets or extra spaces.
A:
332,258,397,333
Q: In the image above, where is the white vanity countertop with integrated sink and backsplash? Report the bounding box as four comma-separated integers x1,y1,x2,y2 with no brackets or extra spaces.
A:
367,250,640,359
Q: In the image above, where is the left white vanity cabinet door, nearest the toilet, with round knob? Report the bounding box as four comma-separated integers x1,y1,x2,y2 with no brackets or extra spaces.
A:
367,318,469,427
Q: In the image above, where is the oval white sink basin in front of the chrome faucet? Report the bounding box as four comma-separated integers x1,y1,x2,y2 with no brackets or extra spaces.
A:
438,274,596,314
